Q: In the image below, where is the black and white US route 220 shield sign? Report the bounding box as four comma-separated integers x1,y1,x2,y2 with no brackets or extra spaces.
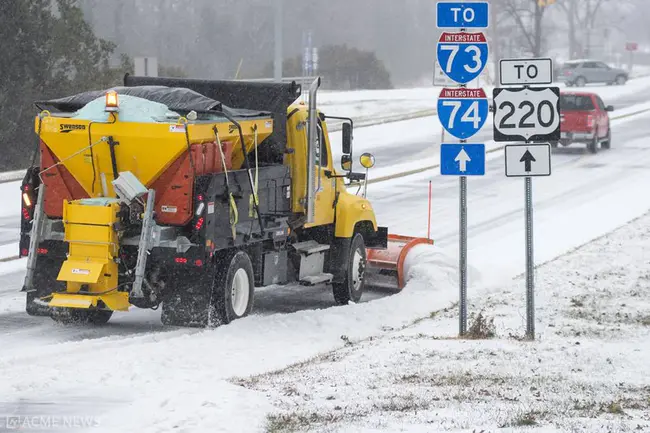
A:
493,87,560,142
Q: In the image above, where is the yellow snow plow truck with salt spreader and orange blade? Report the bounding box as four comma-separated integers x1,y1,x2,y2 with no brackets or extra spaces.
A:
20,75,431,326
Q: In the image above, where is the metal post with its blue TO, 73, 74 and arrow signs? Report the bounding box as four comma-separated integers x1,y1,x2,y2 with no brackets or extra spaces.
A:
434,2,489,337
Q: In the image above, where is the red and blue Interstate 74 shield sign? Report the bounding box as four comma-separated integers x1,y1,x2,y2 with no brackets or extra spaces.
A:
438,87,489,140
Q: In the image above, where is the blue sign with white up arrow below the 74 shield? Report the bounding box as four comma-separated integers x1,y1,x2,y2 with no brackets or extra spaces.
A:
440,144,485,176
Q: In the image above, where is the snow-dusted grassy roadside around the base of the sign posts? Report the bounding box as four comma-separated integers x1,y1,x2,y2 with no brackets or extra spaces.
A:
239,210,650,433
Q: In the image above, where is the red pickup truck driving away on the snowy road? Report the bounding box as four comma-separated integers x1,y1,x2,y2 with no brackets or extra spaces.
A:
551,92,614,153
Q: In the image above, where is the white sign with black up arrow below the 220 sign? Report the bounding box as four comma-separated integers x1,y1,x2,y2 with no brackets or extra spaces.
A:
505,143,551,177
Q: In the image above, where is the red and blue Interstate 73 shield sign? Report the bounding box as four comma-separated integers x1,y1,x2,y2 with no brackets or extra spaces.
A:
436,32,488,84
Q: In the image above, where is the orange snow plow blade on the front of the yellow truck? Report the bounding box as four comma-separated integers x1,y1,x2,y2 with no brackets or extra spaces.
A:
366,235,433,292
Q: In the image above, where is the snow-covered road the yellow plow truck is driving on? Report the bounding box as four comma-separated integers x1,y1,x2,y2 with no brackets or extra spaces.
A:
0,82,650,432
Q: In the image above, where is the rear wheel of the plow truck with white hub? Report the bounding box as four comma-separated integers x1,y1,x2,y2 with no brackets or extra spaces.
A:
208,251,255,326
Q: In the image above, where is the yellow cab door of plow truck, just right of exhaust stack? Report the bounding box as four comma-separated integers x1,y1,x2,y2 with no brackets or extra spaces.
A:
314,119,336,225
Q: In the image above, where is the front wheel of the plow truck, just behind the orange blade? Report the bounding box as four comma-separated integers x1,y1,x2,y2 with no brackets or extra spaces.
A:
332,233,366,305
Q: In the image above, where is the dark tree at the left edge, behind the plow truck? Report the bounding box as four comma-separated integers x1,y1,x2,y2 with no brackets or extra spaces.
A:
0,0,130,171
